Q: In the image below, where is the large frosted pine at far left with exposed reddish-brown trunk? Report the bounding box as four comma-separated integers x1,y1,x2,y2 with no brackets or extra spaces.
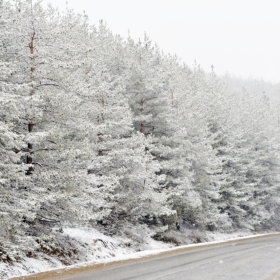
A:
1,0,96,258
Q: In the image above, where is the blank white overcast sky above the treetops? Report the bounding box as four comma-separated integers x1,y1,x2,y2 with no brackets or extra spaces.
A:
44,0,280,83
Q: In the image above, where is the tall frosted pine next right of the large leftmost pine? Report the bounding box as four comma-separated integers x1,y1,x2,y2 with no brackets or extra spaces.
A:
76,26,174,233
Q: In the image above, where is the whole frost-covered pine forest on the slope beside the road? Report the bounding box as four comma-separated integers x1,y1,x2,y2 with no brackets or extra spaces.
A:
0,0,280,276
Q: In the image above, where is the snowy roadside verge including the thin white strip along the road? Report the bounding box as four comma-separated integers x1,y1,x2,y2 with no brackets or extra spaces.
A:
0,228,278,280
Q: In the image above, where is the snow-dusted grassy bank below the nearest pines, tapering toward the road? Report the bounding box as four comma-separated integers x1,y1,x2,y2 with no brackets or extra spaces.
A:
0,228,174,279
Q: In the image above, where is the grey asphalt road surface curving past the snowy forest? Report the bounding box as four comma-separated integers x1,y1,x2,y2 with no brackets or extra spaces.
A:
60,235,280,280
